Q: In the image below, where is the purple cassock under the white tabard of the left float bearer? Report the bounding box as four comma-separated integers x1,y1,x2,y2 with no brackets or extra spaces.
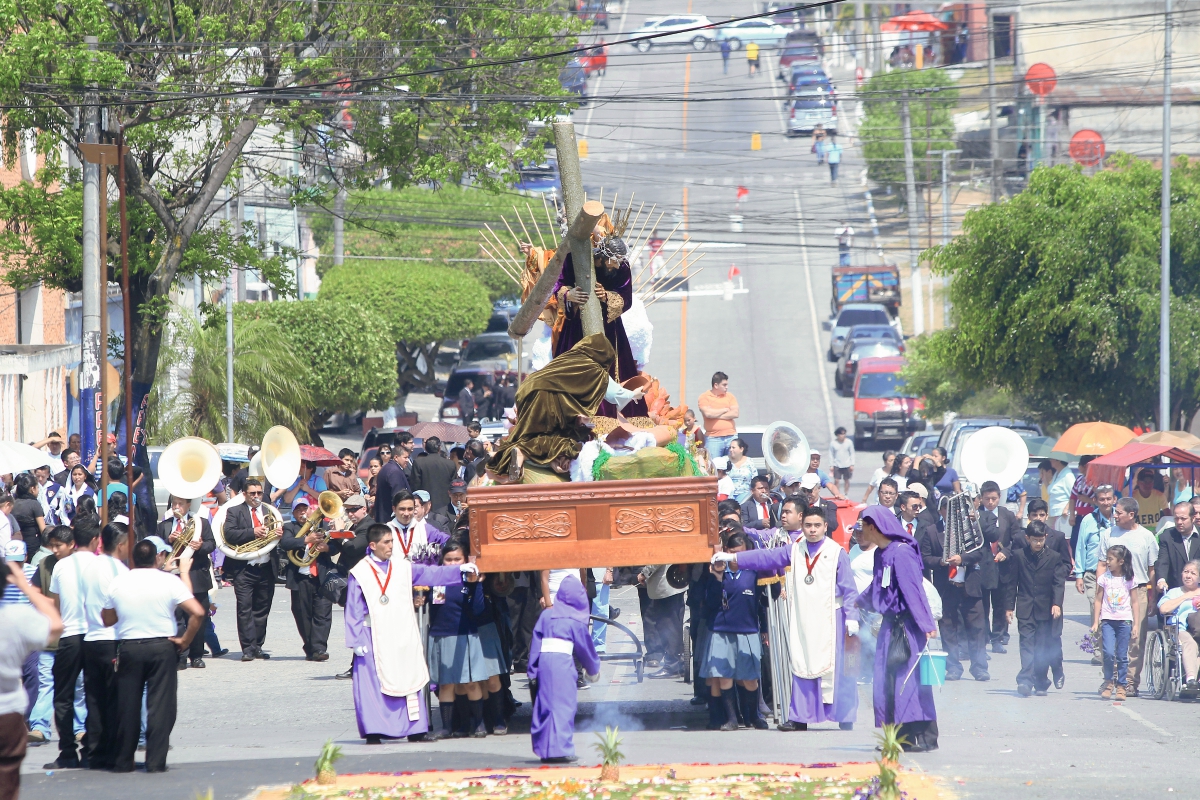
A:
344,563,462,739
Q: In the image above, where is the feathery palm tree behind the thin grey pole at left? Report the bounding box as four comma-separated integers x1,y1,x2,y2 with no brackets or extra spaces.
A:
149,317,312,444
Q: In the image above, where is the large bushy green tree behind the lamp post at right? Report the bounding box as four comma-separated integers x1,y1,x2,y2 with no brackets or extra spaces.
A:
905,154,1200,427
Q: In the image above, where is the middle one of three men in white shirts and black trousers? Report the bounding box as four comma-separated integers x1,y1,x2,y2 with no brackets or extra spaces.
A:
83,522,131,770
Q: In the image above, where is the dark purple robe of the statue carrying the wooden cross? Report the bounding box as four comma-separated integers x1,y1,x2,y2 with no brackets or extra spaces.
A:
554,253,648,417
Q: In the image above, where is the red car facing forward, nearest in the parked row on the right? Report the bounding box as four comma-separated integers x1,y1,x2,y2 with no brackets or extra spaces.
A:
854,356,925,447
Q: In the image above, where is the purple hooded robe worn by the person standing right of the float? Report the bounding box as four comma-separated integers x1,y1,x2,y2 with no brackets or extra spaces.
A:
860,505,937,727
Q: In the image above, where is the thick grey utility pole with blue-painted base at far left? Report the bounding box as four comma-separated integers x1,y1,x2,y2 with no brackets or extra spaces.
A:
79,36,106,465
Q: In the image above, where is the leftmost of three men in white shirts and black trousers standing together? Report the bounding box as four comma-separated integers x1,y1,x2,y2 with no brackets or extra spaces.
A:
44,519,100,770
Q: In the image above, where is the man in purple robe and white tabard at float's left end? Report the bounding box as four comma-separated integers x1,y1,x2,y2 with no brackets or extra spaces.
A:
346,524,478,745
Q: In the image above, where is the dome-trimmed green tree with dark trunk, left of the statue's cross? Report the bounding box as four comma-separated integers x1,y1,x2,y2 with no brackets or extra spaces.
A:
317,261,492,408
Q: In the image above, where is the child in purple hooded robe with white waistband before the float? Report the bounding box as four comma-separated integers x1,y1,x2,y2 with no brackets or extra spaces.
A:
526,576,600,758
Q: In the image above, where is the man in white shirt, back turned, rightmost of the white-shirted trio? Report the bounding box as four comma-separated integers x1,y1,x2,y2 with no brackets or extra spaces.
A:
102,541,204,772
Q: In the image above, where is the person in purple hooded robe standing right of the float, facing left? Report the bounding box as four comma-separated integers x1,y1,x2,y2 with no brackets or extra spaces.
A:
858,505,937,752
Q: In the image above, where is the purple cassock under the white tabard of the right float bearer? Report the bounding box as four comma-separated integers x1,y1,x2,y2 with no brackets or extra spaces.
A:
738,531,858,723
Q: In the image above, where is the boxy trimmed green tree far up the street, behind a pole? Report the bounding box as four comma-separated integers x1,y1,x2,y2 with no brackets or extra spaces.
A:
858,70,959,184
